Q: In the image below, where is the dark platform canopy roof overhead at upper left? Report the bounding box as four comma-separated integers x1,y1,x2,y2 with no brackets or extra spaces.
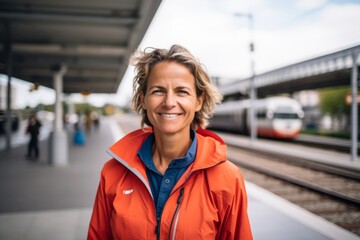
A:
0,0,161,93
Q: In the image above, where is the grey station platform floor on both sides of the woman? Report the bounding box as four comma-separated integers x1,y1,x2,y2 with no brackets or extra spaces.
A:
0,116,360,240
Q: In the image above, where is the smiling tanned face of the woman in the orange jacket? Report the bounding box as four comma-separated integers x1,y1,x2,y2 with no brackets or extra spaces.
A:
142,62,203,137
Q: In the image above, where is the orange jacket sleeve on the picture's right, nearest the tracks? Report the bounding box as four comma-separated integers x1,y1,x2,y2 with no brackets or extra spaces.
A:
220,171,253,240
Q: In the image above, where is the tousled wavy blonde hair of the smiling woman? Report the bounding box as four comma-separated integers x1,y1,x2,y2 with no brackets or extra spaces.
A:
130,45,222,129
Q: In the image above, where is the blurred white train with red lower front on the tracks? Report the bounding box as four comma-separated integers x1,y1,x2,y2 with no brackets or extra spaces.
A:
209,96,304,139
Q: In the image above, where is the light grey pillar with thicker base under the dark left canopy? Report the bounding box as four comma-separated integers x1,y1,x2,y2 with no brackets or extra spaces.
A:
49,62,69,166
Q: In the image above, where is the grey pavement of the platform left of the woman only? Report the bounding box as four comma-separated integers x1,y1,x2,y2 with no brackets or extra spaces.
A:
0,116,118,240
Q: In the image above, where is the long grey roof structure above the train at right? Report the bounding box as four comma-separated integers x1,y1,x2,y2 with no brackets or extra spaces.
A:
221,45,360,98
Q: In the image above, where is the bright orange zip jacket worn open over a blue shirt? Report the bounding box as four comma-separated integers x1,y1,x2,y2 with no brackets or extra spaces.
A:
88,129,252,240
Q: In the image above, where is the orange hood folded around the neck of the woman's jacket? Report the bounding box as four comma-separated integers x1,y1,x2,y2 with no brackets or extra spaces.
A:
107,128,226,173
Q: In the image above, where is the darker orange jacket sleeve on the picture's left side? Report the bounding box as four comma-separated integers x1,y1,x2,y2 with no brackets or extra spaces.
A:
87,174,112,240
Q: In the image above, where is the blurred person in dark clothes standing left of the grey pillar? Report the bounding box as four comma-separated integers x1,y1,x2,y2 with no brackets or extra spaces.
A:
26,113,41,159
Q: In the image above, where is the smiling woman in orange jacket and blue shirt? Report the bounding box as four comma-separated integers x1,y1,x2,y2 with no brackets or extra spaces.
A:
88,45,252,239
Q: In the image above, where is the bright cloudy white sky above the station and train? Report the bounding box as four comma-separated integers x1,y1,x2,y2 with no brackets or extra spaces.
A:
0,0,360,106
